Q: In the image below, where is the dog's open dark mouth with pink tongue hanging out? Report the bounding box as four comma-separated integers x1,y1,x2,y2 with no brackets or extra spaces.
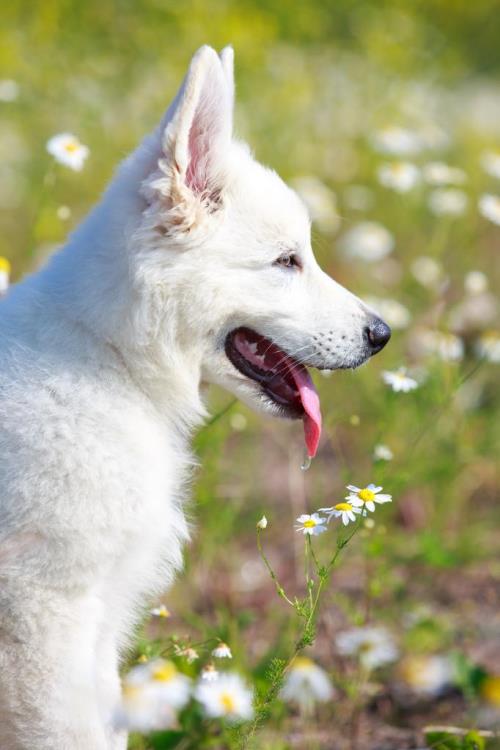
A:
225,327,321,458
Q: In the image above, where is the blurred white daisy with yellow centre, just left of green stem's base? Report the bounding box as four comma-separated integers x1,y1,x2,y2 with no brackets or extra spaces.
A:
194,673,253,723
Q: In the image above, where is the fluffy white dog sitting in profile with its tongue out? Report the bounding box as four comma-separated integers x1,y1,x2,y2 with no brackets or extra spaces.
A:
0,47,390,750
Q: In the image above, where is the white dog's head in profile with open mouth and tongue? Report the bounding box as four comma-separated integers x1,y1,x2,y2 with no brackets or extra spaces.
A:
131,47,390,455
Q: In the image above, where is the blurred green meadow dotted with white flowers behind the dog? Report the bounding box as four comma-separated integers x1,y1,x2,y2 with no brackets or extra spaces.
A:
0,0,500,750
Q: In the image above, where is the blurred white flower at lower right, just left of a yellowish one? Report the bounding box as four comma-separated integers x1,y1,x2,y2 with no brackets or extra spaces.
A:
335,626,398,669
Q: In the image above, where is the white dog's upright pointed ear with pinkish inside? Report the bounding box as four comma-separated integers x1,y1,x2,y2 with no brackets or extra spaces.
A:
148,46,234,209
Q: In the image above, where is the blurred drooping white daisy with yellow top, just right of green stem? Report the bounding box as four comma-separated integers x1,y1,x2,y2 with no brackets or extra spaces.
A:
280,656,334,714
